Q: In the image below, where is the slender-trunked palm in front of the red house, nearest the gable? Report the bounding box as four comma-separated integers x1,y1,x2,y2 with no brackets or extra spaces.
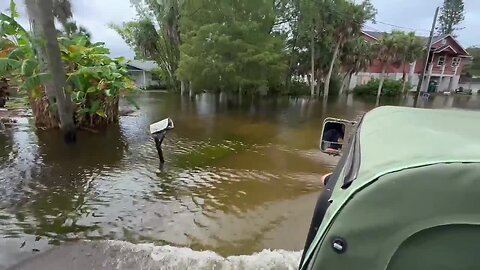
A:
376,32,401,105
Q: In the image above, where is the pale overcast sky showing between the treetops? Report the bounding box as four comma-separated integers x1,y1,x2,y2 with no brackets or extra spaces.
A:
0,0,480,58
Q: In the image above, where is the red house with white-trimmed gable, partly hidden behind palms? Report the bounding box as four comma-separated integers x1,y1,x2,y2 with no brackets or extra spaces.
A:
350,31,471,92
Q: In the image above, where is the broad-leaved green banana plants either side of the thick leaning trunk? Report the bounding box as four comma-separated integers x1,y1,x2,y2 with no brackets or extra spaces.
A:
0,2,138,126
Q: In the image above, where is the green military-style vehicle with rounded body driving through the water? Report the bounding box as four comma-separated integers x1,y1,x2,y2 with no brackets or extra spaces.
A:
300,107,480,270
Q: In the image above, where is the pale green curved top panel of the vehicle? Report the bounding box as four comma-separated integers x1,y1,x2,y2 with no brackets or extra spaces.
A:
357,107,480,184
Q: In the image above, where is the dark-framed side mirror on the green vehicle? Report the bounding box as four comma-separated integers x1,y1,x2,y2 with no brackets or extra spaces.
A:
320,118,356,156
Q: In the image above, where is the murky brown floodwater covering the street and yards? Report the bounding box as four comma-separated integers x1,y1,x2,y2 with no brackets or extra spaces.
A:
0,93,480,269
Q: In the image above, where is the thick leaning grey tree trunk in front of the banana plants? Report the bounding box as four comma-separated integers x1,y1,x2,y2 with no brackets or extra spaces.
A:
35,0,75,141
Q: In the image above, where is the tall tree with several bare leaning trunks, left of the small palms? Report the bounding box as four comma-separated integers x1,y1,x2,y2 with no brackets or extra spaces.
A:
288,0,375,95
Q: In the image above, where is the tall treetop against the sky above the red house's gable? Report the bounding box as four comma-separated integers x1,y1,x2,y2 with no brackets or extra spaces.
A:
437,0,465,34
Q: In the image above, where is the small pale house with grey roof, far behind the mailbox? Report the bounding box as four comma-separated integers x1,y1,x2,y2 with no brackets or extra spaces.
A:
127,60,160,89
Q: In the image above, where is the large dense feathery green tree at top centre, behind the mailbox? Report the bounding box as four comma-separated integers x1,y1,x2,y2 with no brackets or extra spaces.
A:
178,0,287,94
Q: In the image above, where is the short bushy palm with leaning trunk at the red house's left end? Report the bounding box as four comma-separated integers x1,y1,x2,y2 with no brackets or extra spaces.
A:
339,37,375,95
